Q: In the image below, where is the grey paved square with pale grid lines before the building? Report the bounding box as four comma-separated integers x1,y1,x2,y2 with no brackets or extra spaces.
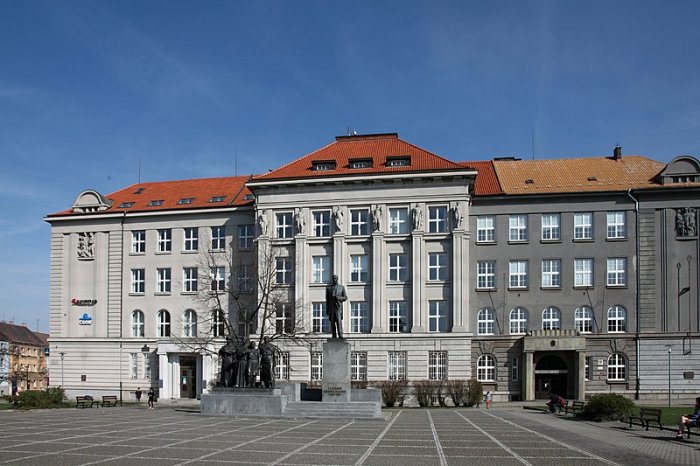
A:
0,406,700,466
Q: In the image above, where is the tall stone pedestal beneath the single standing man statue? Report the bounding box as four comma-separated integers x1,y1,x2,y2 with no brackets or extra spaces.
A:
321,338,350,403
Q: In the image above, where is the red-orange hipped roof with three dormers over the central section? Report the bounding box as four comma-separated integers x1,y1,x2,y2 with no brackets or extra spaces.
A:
253,133,465,181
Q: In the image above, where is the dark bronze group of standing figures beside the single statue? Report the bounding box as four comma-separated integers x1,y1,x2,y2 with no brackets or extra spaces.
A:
219,337,277,388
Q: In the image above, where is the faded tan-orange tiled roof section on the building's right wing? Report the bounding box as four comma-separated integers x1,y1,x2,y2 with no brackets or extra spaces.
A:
492,155,665,195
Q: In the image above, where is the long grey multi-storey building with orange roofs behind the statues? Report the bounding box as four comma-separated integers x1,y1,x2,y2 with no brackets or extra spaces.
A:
46,133,700,399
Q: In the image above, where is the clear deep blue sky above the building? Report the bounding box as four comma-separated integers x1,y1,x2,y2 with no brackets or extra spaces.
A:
0,0,700,331
